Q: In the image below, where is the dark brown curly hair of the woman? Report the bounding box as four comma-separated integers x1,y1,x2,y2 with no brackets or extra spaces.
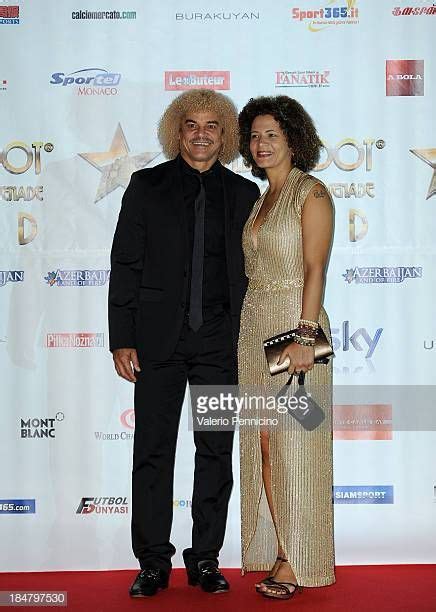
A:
239,96,323,180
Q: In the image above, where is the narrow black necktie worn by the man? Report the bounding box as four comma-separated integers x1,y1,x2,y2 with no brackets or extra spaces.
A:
189,174,206,331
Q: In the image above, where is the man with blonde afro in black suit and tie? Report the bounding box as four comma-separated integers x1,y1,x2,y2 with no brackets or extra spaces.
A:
109,90,259,597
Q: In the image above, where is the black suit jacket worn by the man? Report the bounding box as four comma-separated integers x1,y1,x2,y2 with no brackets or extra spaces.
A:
109,160,259,361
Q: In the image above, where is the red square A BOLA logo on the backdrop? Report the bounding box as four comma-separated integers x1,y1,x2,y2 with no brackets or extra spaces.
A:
386,60,424,96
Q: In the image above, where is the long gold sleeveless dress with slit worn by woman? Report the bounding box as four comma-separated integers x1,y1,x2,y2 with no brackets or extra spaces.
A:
238,168,335,586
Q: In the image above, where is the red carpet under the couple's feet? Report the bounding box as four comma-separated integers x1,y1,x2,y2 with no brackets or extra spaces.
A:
0,565,436,612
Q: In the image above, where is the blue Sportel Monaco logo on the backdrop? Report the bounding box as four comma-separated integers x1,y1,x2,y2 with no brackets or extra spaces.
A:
50,68,121,96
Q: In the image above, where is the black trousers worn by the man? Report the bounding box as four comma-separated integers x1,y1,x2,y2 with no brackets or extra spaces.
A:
132,307,236,571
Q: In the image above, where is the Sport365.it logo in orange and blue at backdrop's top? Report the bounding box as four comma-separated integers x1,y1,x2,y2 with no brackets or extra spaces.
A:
291,0,359,32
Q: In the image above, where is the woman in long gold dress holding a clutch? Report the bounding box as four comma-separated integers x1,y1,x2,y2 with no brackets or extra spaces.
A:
238,96,335,599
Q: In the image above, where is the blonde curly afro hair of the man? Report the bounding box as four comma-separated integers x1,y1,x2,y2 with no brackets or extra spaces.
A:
157,89,239,164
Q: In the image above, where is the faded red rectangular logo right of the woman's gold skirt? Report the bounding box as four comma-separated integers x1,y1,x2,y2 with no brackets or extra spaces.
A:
333,404,392,440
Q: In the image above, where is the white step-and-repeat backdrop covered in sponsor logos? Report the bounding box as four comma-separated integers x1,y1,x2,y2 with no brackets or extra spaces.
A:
0,0,436,571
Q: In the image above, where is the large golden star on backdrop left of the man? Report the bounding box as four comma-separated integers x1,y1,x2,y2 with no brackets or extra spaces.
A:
79,124,160,203
